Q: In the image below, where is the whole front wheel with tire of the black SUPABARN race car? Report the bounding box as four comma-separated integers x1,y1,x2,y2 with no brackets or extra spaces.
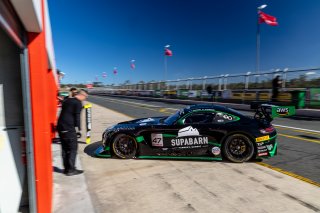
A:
112,134,138,159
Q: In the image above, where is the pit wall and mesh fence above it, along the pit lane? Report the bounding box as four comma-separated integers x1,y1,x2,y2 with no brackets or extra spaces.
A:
90,68,320,108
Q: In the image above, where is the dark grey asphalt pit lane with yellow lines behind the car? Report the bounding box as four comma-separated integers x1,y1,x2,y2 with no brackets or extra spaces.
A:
89,96,320,184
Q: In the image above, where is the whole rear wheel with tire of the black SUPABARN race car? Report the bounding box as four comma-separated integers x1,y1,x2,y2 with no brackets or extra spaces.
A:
222,134,255,163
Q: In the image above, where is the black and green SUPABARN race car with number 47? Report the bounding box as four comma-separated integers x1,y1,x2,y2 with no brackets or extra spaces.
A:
95,104,295,163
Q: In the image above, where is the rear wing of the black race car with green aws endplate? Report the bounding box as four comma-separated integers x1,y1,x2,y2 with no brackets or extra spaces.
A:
251,102,296,122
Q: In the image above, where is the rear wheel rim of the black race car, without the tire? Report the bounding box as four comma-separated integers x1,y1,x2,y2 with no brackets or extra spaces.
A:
228,136,253,160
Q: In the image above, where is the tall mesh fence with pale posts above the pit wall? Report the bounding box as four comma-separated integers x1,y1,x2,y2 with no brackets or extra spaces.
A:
107,68,320,91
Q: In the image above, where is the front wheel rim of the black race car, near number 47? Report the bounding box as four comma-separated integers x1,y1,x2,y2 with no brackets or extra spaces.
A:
113,135,137,158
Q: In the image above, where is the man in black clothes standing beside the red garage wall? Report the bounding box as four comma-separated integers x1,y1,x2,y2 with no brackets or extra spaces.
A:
57,90,88,176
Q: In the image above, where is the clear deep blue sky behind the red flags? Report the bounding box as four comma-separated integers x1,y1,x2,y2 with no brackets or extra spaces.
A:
48,0,320,84
